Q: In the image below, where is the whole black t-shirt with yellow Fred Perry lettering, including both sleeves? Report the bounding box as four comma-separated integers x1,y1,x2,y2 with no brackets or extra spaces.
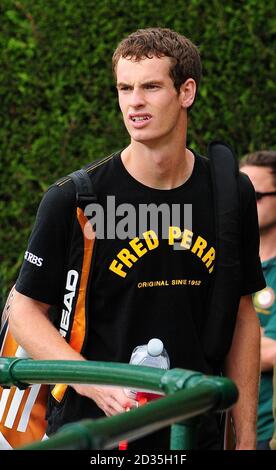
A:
16,153,264,444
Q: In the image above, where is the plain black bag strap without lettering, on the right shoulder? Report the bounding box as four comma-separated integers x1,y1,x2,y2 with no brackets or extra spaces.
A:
203,142,241,361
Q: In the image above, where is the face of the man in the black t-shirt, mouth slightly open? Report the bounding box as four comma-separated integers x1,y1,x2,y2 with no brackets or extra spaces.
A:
117,57,188,144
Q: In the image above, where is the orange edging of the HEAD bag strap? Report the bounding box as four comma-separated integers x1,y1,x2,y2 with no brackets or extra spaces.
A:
51,207,95,402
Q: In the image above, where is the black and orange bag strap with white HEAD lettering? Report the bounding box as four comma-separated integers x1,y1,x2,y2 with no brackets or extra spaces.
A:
51,168,97,402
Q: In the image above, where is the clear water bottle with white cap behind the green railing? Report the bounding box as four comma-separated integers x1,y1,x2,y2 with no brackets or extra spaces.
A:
126,338,170,404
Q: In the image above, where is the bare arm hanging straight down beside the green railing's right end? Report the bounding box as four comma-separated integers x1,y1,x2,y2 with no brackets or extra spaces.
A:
225,295,260,450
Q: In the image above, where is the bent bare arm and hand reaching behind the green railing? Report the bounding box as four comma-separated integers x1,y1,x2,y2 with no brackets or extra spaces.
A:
9,291,136,416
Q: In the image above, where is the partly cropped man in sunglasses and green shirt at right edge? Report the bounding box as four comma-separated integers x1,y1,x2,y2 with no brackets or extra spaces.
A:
240,150,276,450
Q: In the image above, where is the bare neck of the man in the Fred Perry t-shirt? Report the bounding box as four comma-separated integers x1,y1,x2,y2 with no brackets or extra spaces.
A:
122,142,194,189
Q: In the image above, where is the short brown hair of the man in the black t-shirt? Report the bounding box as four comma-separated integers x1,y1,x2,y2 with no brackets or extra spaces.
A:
112,28,201,92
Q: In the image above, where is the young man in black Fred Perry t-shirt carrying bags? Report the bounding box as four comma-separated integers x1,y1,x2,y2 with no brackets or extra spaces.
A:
7,28,264,449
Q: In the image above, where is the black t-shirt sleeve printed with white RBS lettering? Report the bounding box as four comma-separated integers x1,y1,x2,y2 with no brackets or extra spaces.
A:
16,183,74,305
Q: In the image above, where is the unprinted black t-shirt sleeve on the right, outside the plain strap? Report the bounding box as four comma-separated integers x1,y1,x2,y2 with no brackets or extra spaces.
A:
240,174,266,295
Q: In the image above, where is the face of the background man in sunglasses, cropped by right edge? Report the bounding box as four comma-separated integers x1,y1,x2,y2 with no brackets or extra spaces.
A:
241,165,276,233
